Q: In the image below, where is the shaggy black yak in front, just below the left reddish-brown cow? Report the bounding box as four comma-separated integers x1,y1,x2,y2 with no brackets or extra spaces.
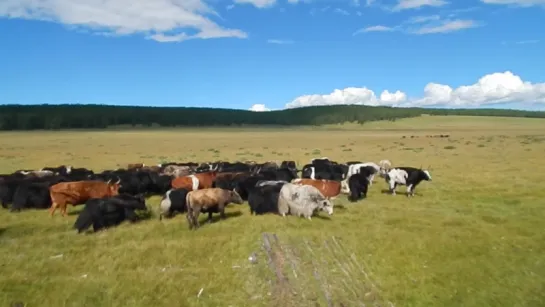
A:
74,194,147,233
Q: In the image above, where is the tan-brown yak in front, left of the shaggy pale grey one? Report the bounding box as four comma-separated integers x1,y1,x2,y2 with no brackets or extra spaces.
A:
185,188,243,230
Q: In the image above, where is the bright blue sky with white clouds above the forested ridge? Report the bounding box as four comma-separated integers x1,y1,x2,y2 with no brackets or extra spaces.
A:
0,0,545,111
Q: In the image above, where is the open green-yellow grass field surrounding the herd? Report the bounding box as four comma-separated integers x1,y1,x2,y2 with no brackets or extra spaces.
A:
0,117,545,307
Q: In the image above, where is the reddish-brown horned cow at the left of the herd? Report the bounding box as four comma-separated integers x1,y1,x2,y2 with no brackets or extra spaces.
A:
49,181,121,216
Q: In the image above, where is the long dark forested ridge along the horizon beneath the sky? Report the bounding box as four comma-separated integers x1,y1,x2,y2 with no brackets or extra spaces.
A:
0,105,545,130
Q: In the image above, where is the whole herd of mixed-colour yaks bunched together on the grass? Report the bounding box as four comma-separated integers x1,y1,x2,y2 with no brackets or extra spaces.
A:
0,158,431,232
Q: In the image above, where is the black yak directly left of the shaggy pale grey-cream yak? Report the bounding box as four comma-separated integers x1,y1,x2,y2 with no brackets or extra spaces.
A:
248,181,287,215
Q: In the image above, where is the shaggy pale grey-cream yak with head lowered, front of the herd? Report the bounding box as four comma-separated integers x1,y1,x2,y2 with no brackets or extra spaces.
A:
278,183,333,220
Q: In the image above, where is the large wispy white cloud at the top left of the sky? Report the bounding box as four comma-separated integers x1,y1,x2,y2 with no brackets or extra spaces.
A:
0,0,247,42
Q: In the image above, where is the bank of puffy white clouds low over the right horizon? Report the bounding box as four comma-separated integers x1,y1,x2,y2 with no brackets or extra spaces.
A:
286,71,545,108
